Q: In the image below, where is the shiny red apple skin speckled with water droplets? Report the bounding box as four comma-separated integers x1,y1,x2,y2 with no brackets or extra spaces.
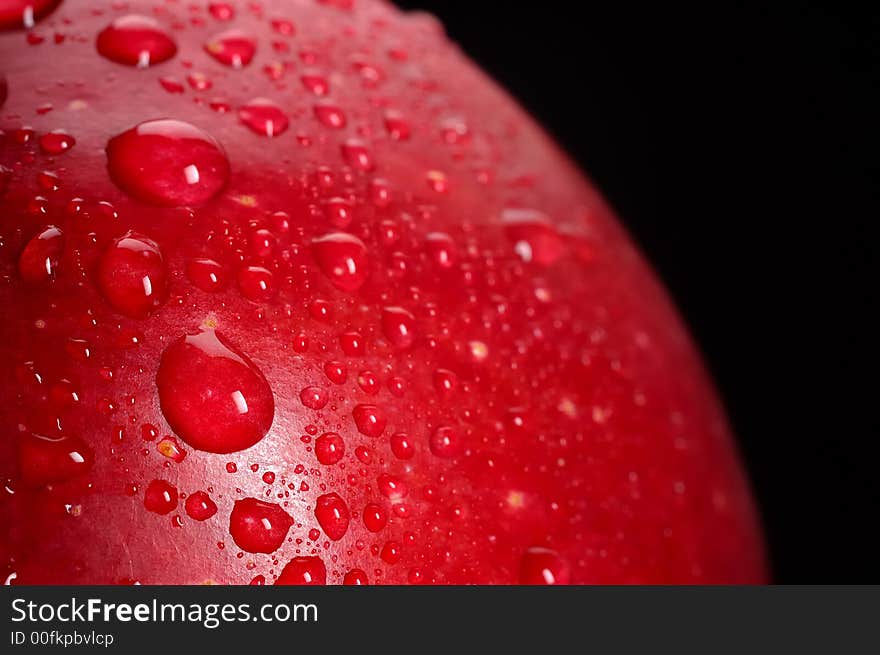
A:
0,0,767,584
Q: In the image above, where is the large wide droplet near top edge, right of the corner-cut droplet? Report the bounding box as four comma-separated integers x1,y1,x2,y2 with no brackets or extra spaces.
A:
97,14,177,68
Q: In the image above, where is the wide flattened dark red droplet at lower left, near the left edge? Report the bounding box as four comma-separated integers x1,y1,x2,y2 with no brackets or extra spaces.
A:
18,434,94,486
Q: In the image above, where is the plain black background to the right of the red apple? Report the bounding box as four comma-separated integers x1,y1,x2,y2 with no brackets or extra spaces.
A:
399,0,880,583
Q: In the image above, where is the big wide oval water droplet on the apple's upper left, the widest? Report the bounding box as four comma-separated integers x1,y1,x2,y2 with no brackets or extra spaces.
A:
107,119,229,206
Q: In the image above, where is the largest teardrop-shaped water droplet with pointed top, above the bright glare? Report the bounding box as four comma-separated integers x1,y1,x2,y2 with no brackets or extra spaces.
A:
156,330,275,453
